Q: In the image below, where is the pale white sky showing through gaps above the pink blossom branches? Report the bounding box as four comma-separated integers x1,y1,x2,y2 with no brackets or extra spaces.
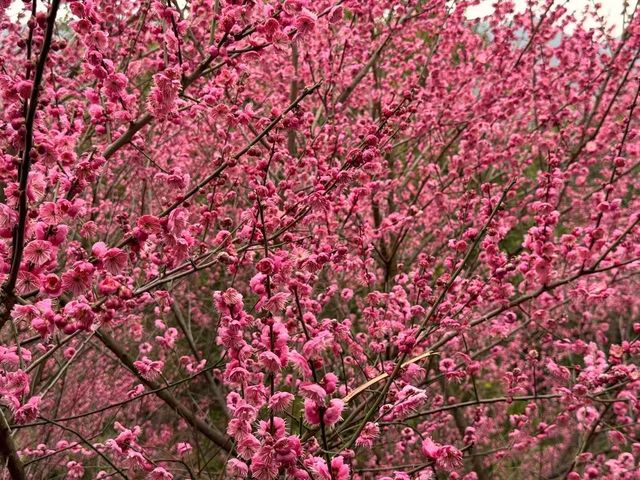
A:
7,0,637,35
